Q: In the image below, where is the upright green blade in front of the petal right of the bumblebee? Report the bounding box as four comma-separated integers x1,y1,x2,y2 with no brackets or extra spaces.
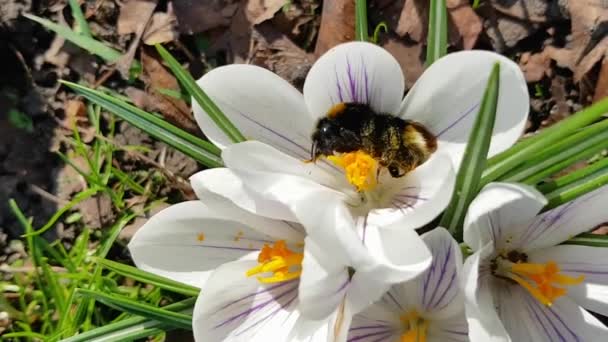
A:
439,63,500,241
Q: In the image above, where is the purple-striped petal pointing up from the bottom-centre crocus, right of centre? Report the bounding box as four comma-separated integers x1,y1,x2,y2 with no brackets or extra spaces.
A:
418,227,464,319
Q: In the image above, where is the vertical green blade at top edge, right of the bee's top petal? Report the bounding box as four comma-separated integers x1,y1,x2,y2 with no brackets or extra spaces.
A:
426,0,448,66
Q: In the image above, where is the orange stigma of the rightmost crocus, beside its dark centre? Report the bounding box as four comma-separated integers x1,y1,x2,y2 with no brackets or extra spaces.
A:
506,261,585,306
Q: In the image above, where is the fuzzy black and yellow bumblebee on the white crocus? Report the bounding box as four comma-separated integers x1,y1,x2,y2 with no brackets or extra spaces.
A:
311,103,437,178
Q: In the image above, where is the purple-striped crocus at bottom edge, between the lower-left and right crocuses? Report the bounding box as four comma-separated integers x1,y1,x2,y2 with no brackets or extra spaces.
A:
347,227,468,342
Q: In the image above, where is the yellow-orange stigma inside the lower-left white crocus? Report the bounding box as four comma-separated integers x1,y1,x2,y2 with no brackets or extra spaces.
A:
246,240,304,284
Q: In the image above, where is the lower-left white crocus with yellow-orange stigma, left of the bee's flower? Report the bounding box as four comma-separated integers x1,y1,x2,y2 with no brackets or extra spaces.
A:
129,189,385,342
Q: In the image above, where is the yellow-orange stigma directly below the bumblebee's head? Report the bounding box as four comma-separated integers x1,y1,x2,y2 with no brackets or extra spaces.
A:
327,151,378,191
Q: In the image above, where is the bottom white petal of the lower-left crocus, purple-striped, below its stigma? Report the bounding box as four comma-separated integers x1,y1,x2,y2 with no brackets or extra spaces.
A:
192,260,299,342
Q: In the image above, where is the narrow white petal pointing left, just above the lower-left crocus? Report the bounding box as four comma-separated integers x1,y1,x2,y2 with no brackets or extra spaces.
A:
190,168,295,221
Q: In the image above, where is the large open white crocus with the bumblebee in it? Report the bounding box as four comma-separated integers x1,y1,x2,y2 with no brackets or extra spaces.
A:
193,42,529,292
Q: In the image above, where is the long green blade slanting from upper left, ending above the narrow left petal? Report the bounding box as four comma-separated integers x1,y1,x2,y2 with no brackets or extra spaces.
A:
61,81,223,167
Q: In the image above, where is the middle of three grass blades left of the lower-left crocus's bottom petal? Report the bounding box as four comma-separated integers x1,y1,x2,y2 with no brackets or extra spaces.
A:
78,289,192,330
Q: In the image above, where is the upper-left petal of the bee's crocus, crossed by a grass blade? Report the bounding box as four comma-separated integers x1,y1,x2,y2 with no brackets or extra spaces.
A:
192,64,314,158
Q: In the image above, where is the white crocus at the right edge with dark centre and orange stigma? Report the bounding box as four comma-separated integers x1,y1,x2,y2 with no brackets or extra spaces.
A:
463,183,608,342
